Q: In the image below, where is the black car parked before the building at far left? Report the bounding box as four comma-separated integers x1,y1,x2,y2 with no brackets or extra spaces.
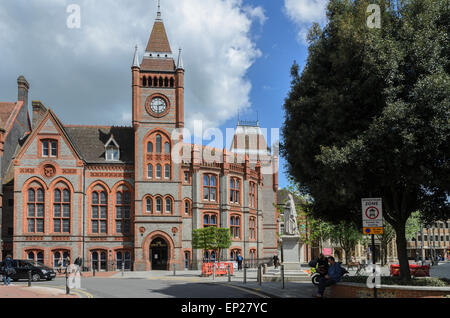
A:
0,260,56,282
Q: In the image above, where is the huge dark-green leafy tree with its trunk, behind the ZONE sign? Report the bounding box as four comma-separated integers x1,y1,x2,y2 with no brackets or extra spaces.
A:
281,0,450,280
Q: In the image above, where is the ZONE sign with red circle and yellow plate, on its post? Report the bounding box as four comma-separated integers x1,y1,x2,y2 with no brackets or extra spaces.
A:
361,198,383,298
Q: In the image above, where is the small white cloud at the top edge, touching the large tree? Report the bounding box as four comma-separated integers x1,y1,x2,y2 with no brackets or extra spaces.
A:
283,0,328,44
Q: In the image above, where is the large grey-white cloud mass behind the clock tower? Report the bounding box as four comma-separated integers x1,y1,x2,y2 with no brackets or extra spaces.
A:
0,0,267,132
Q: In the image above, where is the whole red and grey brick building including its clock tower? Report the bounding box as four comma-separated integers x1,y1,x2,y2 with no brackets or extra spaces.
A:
3,7,278,270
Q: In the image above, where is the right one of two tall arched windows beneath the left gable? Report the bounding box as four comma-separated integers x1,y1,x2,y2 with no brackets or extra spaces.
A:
53,188,71,233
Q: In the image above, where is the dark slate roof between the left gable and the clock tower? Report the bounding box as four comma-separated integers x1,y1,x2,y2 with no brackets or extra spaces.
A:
64,125,134,164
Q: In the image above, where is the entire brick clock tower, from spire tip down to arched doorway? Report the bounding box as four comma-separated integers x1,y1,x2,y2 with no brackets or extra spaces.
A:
131,6,184,270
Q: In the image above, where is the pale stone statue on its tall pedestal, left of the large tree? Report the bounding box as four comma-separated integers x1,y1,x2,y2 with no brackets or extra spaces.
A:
281,194,301,271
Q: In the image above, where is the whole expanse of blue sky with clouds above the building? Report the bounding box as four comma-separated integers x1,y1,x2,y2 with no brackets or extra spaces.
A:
0,0,327,187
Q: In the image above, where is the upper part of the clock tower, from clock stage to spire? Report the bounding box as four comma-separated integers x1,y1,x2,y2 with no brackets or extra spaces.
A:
132,6,184,130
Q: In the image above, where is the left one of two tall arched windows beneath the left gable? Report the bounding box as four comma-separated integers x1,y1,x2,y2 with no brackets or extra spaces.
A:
27,188,44,233
